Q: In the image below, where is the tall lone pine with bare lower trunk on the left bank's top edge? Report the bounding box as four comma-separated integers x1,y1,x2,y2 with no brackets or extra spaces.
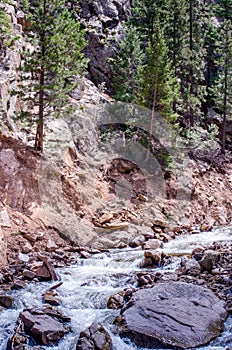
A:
19,0,87,151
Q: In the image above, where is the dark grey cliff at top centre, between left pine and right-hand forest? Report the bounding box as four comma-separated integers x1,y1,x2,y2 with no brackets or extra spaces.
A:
77,0,130,91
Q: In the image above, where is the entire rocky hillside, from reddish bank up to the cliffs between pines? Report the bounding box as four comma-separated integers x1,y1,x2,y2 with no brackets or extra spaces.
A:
0,1,232,268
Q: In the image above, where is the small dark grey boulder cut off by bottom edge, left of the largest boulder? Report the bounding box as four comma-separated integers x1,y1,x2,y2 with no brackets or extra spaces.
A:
76,322,112,350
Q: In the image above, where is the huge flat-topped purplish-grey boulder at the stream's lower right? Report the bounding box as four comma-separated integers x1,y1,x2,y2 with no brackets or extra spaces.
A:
119,282,227,349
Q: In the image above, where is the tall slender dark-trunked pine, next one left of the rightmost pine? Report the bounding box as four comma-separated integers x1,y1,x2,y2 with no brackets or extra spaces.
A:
176,0,207,127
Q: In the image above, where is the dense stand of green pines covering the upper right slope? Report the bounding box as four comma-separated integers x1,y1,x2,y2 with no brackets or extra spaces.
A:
113,0,232,153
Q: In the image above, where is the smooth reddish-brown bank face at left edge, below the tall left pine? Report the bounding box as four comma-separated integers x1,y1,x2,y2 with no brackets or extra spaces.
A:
0,135,40,213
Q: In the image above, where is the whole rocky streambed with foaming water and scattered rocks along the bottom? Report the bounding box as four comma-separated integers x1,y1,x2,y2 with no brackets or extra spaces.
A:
0,227,232,350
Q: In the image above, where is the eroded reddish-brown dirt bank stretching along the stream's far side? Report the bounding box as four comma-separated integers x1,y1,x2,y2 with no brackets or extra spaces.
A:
0,129,232,257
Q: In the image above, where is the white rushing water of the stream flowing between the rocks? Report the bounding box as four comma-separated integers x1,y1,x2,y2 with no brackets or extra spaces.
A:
0,227,232,350
